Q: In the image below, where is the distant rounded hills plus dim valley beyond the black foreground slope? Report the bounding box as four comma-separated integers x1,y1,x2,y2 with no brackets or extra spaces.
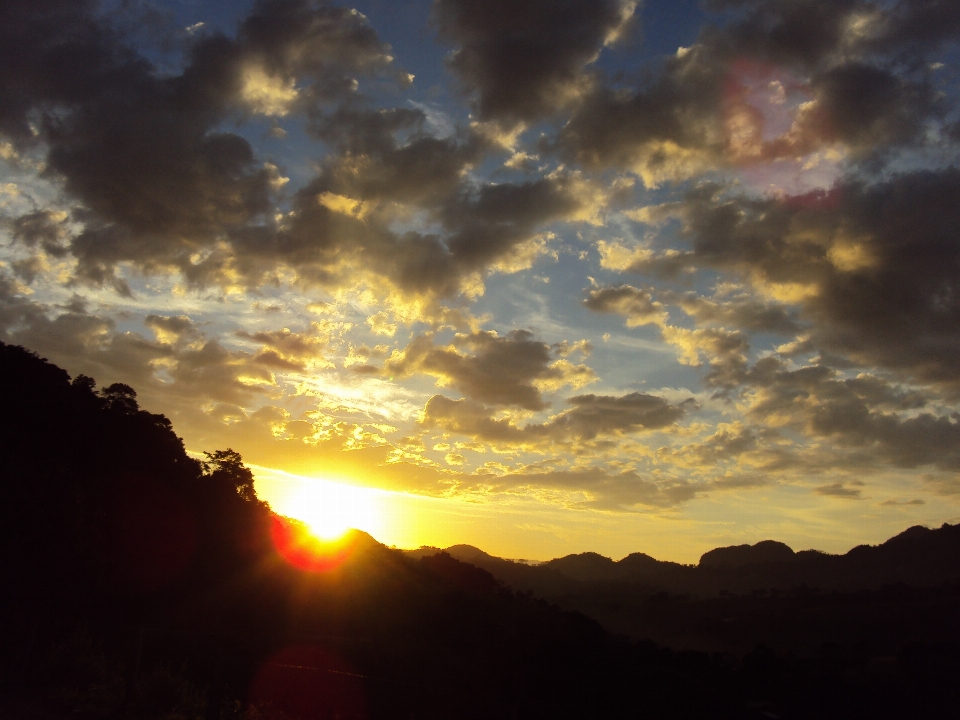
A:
409,525,960,653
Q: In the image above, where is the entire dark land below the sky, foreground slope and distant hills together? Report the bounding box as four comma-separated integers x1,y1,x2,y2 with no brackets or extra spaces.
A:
0,343,960,720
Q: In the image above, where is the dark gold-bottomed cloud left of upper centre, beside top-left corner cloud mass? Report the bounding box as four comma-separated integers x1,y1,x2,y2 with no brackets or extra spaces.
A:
234,155,606,297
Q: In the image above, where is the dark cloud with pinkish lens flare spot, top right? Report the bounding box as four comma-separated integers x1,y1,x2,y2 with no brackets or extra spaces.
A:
558,0,960,184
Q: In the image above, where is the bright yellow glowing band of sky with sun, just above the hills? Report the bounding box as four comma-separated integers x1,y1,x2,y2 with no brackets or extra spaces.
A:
250,465,960,563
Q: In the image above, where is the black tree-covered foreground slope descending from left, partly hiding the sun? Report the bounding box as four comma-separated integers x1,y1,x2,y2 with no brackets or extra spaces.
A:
0,345,960,720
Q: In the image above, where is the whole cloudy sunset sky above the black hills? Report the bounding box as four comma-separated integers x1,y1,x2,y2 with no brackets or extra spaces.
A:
0,0,960,562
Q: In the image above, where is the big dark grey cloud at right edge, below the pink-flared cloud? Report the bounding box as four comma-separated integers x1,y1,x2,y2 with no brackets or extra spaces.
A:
687,168,960,383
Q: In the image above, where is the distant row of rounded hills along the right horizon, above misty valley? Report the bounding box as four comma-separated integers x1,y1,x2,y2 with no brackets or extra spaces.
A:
407,523,960,598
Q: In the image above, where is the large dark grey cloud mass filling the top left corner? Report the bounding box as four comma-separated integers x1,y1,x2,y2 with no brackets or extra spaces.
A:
0,0,389,283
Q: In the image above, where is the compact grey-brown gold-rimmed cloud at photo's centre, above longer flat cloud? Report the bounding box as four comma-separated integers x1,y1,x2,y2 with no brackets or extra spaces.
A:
383,330,596,411
